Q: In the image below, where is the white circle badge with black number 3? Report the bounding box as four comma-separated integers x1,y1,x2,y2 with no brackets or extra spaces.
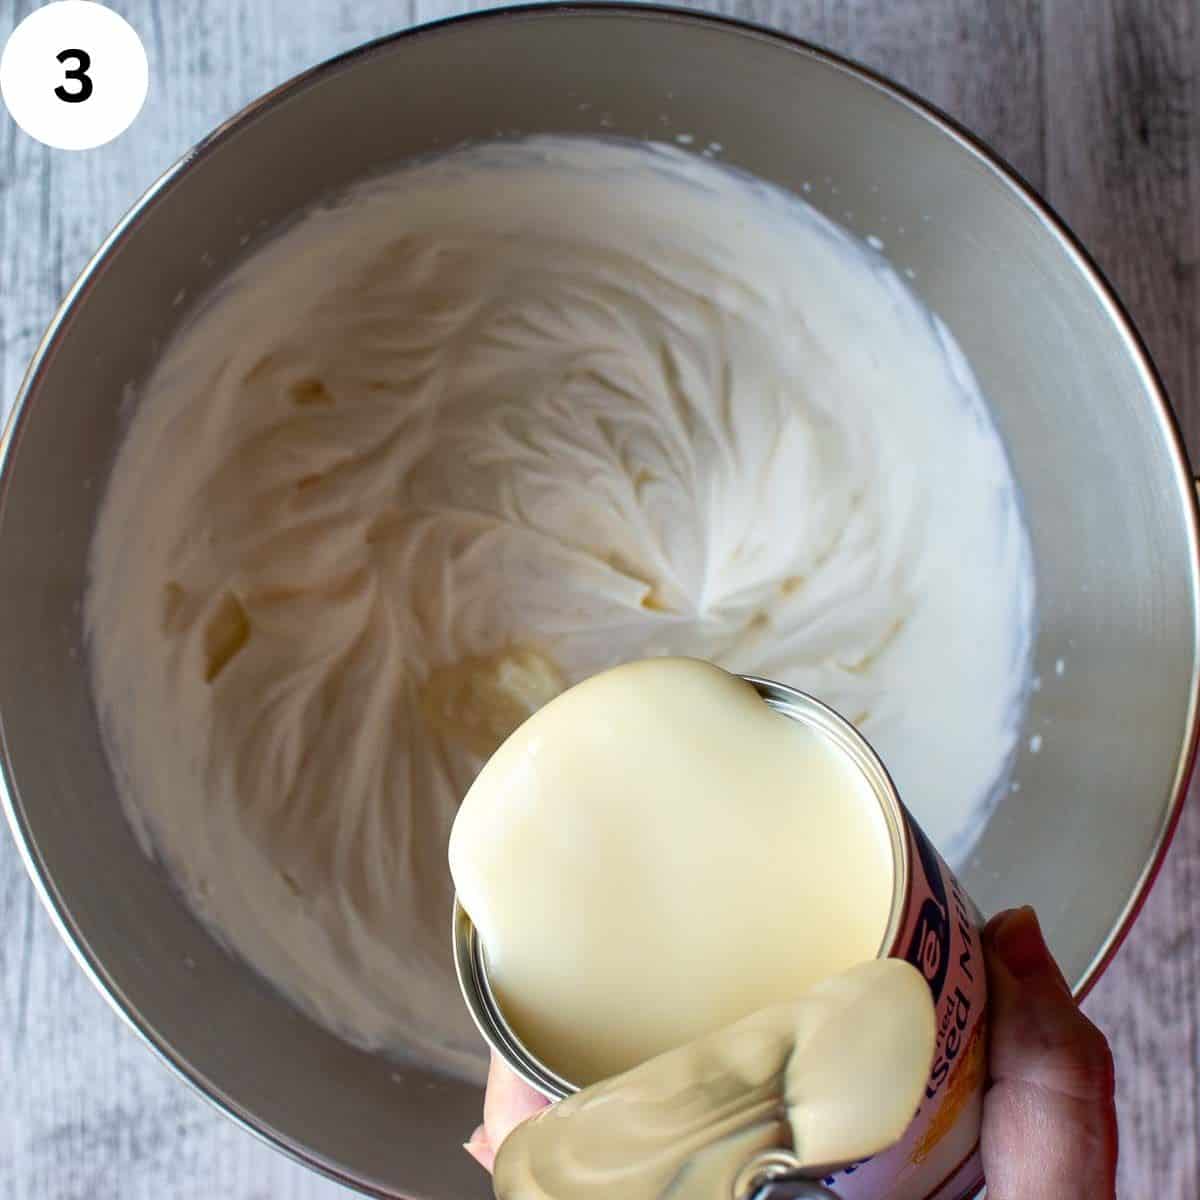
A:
0,0,150,150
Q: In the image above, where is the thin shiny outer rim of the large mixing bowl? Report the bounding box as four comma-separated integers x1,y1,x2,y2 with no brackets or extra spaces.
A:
0,0,1200,1200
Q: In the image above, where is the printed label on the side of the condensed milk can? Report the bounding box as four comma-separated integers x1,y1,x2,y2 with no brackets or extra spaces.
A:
822,805,988,1200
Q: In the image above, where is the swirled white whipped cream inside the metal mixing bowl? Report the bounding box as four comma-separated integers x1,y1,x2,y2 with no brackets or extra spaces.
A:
85,139,1030,1070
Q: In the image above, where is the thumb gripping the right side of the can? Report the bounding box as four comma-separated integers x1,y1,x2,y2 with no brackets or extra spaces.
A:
982,908,1117,1200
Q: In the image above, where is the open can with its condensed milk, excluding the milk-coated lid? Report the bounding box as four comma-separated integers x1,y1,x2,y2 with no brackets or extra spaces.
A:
450,659,985,1200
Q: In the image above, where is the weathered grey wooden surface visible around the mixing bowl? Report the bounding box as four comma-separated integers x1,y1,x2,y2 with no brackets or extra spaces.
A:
0,0,1200,1200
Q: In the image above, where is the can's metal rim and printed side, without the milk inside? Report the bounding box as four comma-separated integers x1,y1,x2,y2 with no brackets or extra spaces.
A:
454,676,986,1200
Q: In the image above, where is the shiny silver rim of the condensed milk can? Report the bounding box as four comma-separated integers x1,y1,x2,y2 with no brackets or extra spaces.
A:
451,676,912,1100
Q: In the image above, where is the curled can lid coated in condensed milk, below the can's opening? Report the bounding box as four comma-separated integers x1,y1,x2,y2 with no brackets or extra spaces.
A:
494,959,936,1200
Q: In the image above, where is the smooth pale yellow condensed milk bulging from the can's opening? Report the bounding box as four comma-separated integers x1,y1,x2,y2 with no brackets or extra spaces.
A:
450,659,894,1086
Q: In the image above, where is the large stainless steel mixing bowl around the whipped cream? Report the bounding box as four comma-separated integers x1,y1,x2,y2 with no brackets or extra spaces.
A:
0,5,1198,1200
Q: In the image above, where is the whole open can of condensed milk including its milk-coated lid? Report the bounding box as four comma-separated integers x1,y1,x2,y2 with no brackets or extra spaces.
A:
450,659,985,1200
